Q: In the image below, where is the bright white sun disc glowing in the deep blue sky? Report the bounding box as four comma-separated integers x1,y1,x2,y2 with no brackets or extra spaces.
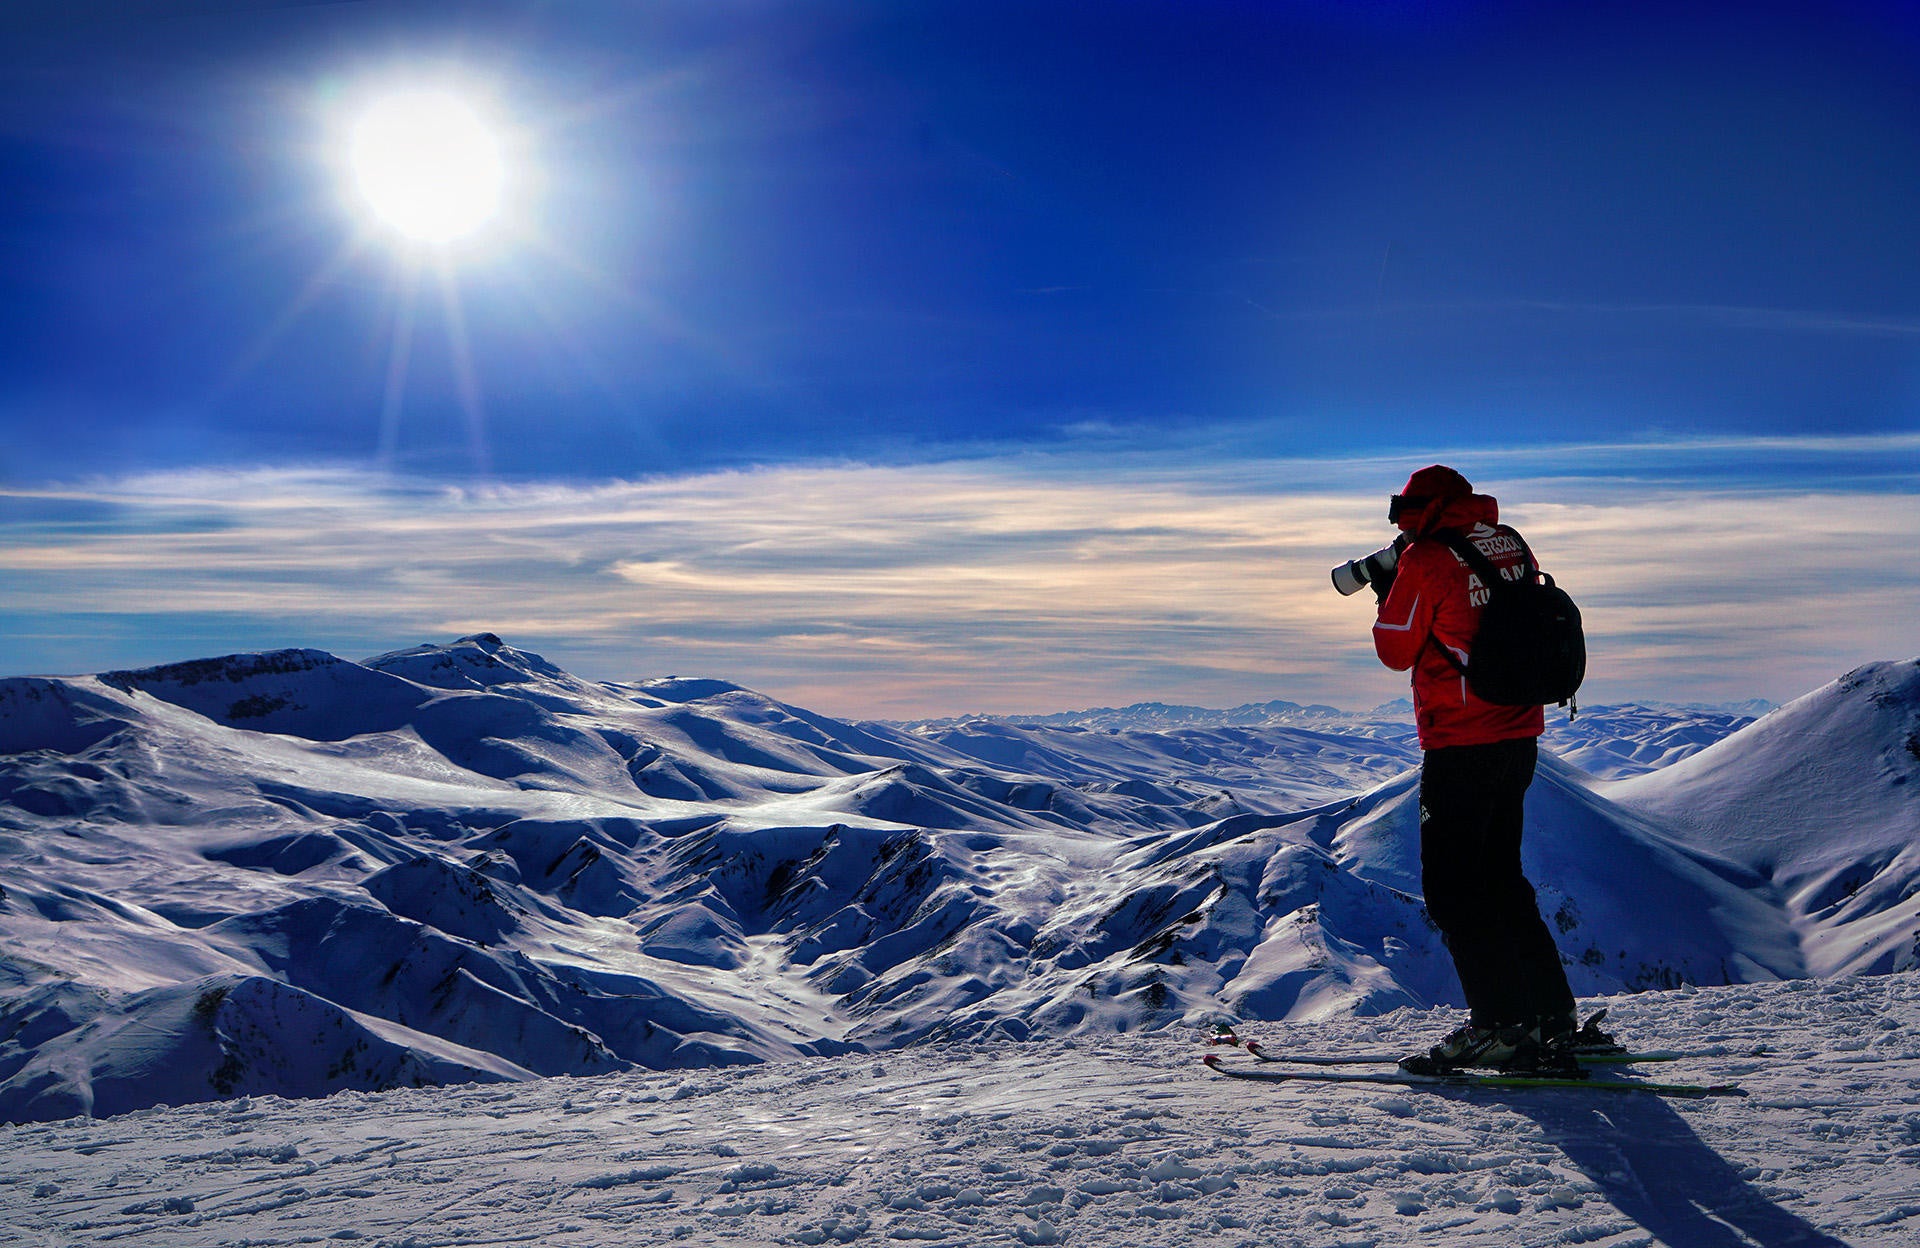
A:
348,90,507,244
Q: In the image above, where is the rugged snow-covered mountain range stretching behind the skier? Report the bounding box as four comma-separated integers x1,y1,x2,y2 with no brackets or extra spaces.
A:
0,636,1920,1119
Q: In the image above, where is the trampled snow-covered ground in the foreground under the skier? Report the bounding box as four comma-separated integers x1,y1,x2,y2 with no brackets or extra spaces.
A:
0,973,1920,1248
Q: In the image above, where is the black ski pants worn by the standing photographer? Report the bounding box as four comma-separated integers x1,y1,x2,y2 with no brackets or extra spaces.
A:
1421,737,1574,1027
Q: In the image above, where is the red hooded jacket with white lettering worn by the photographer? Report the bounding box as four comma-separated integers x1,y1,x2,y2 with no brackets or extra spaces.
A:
1373,468,1546,749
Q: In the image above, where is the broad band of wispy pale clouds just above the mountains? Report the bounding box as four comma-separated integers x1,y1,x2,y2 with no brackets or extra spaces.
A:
0,438,1920,716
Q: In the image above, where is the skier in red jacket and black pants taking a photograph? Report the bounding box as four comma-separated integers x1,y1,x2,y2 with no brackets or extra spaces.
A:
1373,465,1603,1073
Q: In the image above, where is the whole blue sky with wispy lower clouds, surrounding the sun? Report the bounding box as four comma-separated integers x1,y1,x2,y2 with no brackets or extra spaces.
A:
0,0,1920,714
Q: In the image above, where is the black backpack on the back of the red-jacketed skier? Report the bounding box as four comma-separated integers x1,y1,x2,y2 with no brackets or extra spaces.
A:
1432,524,1586,707
